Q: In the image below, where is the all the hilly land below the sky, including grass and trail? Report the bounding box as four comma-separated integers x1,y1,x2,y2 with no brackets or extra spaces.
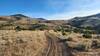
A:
0,14,100,56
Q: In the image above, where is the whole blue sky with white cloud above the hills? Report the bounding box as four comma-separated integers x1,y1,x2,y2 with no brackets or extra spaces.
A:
0,0,100,20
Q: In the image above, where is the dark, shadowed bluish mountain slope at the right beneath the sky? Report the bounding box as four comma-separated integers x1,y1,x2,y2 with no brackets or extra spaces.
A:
69,14,100,29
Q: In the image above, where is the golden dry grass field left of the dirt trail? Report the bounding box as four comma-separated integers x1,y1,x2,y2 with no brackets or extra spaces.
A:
0,30,46,56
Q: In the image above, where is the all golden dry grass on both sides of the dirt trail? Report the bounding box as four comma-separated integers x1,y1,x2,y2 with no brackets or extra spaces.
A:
0,30,100,56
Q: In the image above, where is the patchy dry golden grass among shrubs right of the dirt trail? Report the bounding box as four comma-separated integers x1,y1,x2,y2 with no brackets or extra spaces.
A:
50,30,100,56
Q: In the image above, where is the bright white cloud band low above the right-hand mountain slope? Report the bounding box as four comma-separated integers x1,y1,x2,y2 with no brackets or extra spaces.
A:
46,9,100,20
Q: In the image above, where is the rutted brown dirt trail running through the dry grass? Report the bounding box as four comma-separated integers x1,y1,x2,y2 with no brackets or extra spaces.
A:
42,31,73,56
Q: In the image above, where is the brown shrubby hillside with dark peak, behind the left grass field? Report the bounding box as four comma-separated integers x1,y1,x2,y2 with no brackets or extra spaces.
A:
0,14,69,30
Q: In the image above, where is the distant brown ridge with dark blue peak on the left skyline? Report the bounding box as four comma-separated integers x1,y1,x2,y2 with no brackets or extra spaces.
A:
0,14,45,24
